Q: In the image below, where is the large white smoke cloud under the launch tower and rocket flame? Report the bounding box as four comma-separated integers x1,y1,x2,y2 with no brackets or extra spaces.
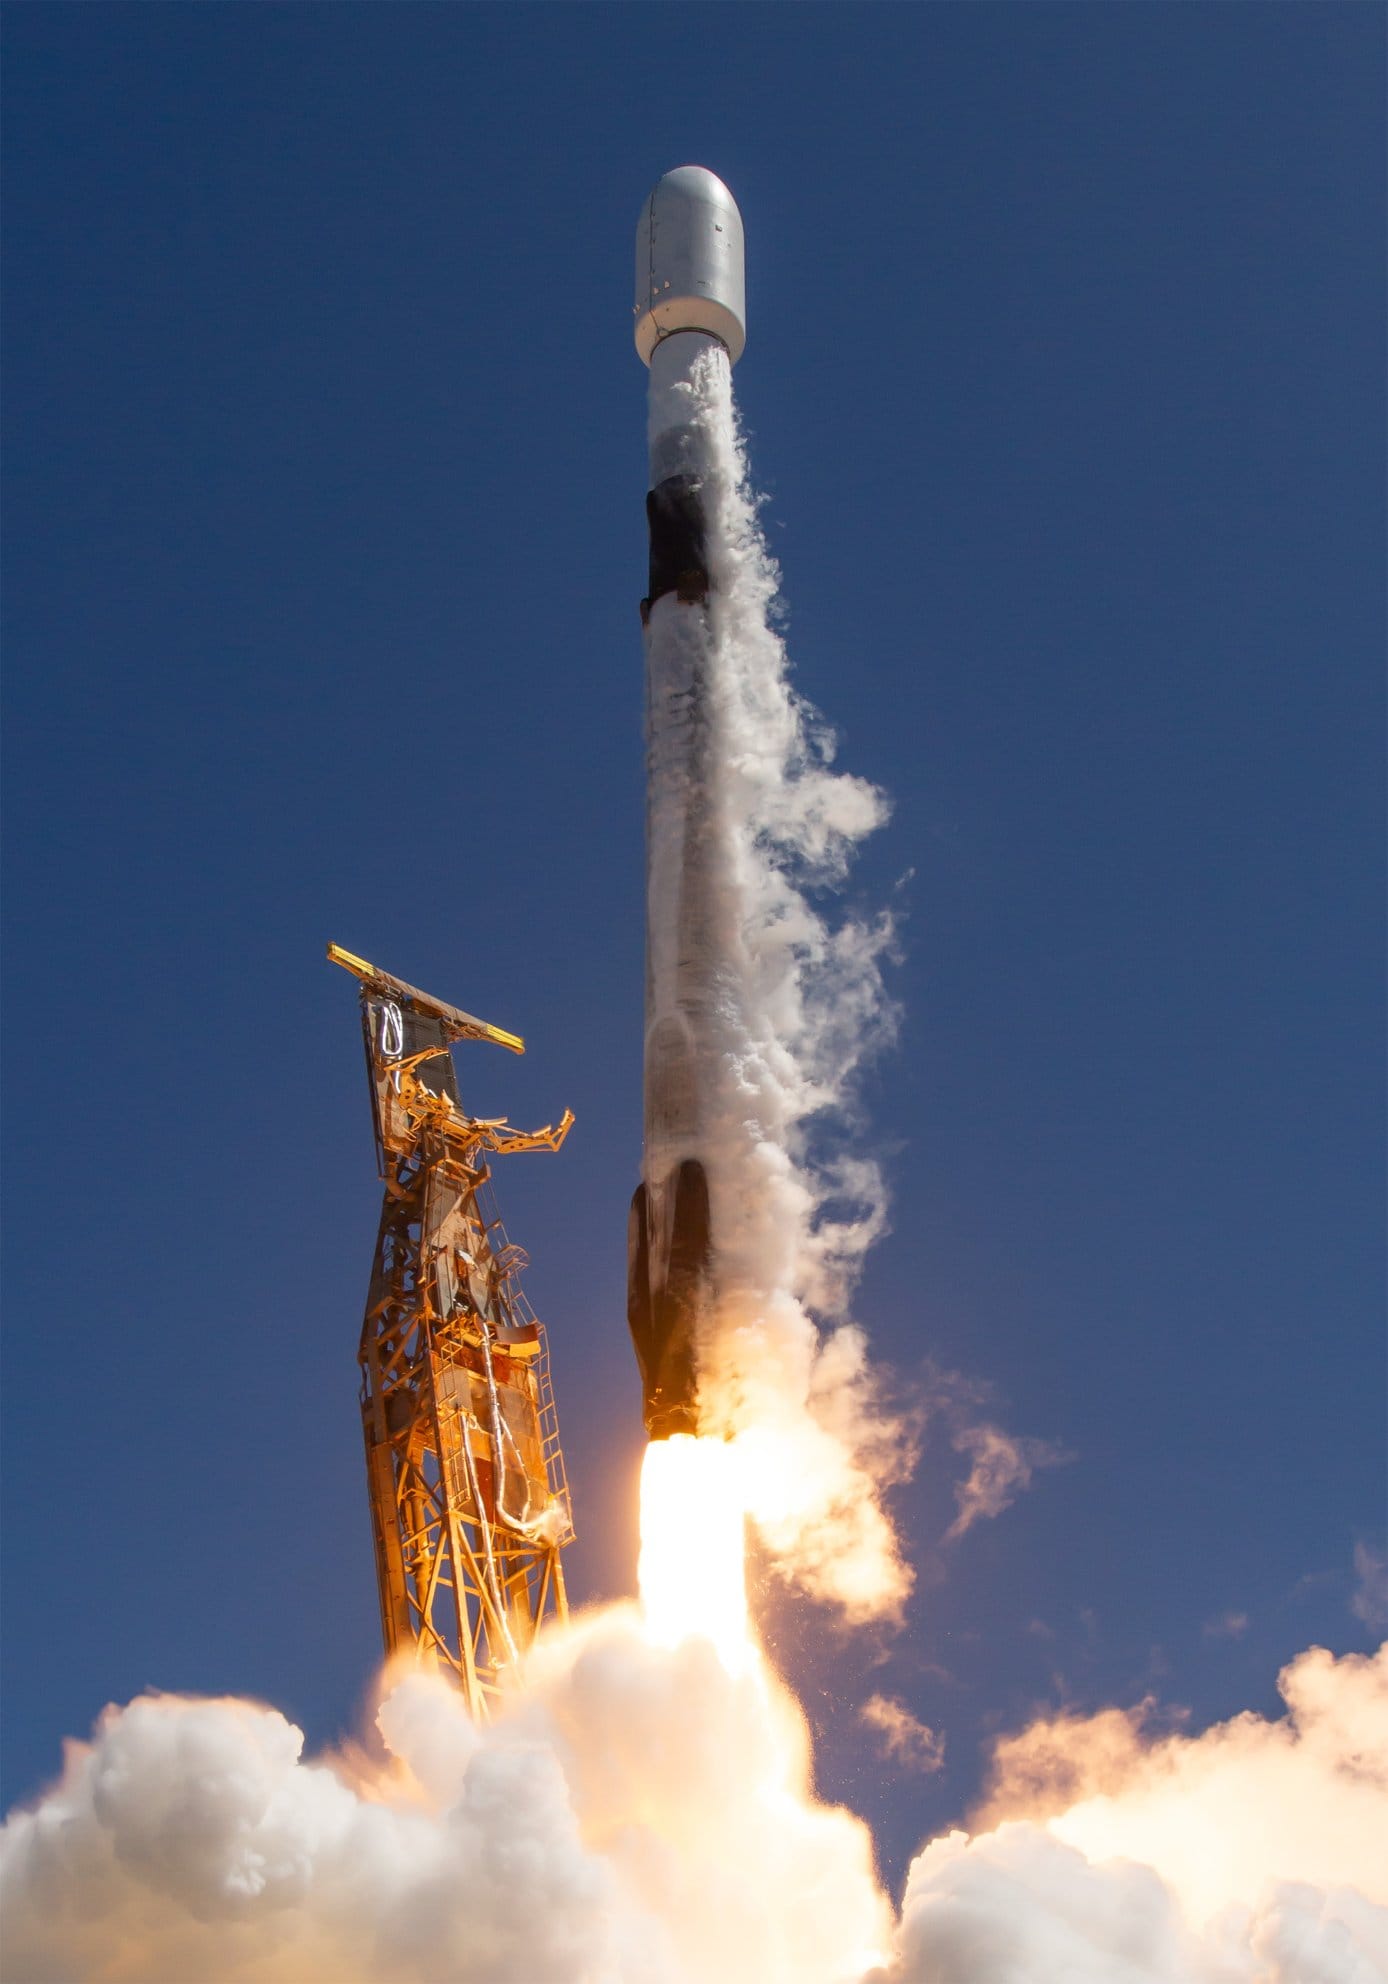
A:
0,1609,890,1984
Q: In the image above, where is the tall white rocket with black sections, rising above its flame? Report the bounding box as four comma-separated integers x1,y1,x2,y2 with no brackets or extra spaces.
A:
627,165,746,1440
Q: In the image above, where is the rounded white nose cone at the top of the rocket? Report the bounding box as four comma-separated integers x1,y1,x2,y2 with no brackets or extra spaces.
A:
635,165,748,365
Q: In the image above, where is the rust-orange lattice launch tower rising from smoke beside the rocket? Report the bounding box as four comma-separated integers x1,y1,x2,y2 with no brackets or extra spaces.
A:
327,944,573,1716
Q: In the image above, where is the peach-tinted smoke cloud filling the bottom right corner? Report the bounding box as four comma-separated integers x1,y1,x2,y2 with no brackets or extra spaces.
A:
884,1647,1388,1984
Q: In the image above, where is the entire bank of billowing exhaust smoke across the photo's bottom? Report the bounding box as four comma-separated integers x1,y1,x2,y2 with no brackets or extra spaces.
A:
0,1634,1388,1984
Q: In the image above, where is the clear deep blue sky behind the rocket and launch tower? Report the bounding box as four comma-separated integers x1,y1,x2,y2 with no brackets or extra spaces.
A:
4,4,1384,1865
